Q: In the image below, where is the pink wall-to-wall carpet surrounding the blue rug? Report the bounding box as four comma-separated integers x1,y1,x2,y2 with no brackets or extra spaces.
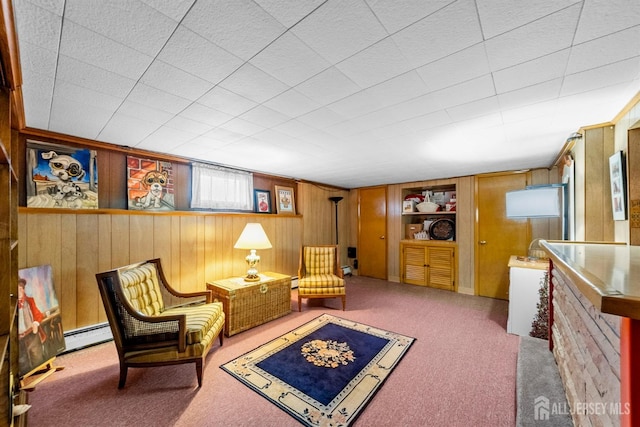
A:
28,276,520,427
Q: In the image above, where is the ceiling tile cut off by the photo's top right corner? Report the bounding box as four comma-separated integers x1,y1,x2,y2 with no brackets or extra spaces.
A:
574,0,640,44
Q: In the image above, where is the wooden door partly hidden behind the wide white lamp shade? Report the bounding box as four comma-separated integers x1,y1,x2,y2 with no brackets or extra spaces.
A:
475,173,531,299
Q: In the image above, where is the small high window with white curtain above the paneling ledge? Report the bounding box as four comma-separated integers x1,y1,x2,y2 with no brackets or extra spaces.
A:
191,163,253,211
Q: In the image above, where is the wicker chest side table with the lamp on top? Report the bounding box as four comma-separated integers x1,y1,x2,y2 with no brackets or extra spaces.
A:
207,272,291,336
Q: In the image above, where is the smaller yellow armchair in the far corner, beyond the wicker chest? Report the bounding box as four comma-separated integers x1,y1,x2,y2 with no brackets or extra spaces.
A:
298,245,347,311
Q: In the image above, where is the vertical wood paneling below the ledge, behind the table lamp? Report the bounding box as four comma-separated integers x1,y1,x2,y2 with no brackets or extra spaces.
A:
18,208,302,331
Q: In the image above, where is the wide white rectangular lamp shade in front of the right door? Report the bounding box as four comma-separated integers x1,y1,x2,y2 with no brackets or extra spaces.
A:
507,187,562,218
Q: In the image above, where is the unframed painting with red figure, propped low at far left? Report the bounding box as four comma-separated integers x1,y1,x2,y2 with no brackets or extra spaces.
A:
18,265,66,377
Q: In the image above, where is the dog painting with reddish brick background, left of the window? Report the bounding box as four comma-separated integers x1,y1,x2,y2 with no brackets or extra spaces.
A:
127,156,175,211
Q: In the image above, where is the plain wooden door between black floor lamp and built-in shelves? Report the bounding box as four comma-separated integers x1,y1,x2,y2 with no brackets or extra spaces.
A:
358,187,387,280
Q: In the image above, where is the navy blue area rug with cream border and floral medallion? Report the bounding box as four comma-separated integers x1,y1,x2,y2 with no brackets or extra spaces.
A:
221,314,414,426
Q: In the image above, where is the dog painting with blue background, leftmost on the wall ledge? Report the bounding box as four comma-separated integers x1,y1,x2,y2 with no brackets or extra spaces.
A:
26,141,98,209
